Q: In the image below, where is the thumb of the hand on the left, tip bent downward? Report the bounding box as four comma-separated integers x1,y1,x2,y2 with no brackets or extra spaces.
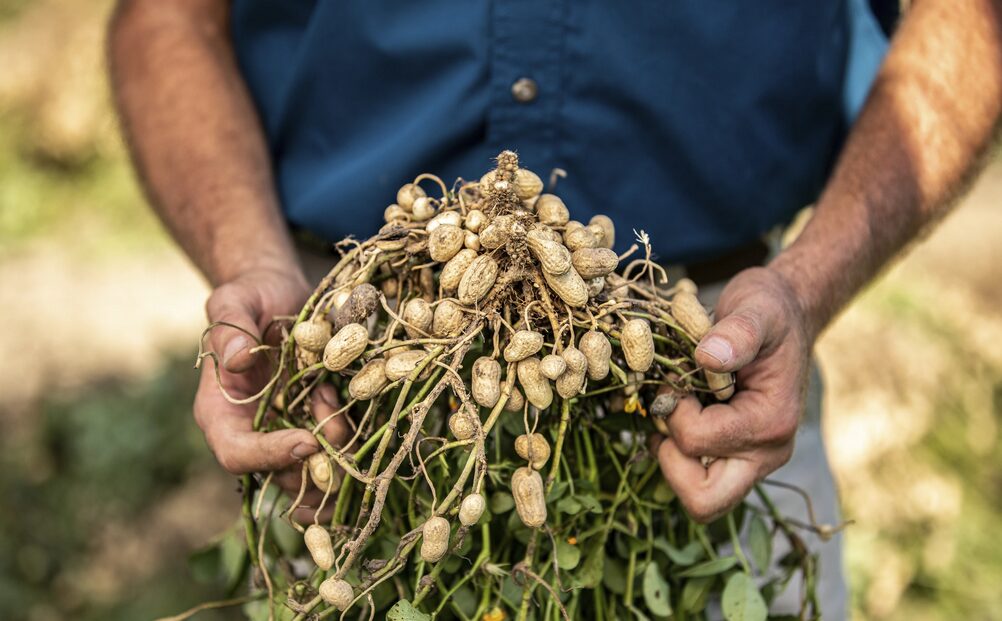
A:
205,284,261,373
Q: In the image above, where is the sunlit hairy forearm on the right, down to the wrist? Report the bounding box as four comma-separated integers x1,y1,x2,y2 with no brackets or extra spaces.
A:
771,0,1002,337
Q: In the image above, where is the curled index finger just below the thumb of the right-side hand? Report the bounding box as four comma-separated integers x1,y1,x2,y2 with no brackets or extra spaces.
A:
667,391,799,458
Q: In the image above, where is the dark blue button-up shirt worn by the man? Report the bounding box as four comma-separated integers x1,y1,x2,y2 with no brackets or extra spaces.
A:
231,0,869,261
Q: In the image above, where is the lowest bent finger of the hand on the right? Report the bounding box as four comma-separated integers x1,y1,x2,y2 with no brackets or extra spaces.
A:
657,438,759,524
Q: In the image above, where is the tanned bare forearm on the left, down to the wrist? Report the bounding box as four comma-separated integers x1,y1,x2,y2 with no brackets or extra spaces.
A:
109,0,299,285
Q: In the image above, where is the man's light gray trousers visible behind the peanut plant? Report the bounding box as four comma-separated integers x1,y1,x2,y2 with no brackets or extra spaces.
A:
300,246,849,621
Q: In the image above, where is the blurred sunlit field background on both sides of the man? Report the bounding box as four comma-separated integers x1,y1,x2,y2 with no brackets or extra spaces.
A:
0,0,1002,621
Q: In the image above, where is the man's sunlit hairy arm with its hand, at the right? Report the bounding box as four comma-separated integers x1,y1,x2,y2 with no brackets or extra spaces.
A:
656,0,1002,521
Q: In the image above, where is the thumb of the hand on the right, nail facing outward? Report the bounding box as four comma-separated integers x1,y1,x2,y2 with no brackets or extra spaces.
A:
695,307,766,373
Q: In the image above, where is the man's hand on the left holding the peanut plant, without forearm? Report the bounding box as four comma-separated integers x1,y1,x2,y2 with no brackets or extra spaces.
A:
194,268,350,516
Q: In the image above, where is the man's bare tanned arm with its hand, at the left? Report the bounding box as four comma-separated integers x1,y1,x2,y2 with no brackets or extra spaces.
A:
108,0,347,504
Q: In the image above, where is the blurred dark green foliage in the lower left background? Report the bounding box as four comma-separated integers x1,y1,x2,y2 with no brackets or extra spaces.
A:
0,357,235,621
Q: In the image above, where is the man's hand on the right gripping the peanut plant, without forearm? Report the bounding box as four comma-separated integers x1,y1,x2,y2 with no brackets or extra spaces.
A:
654,267,812,522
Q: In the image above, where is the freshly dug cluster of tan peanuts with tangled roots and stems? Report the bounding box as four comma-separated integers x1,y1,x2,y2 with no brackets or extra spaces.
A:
188,151,813,619
